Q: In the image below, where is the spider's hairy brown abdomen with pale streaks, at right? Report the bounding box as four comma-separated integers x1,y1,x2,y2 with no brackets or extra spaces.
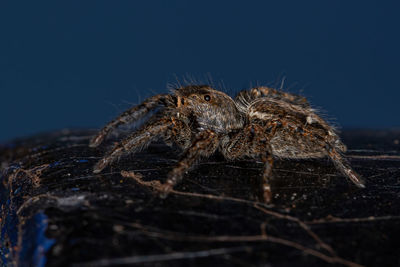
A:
247,97,344,159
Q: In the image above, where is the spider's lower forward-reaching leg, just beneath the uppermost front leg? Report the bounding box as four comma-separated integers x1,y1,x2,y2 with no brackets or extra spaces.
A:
93,118,174,173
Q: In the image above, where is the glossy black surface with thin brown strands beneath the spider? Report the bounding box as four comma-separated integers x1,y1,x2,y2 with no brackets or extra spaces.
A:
0,130,400,266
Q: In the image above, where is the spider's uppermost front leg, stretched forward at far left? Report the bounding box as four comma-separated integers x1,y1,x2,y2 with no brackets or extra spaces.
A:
89,94,167,147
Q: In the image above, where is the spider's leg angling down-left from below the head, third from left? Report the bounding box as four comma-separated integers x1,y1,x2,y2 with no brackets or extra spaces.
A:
160,130,218,198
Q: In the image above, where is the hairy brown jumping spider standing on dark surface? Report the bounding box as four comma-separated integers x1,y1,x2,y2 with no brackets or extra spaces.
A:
90,85,365,202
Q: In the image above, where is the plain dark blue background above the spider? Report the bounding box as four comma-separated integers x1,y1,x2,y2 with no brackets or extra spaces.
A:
0,0,400,141
